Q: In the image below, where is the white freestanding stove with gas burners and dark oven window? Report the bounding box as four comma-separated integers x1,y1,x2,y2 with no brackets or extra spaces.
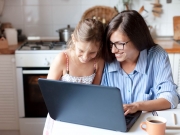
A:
15,41,67,135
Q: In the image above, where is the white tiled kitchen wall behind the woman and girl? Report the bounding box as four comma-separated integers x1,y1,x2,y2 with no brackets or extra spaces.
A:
0,0,180,37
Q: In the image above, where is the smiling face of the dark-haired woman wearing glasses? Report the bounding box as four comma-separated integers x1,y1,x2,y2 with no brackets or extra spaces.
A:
110,30,139,62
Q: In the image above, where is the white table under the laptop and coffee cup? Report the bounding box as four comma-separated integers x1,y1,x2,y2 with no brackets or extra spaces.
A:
49,105,180,135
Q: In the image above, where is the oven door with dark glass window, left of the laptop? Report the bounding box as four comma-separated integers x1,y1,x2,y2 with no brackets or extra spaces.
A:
17,68,49,118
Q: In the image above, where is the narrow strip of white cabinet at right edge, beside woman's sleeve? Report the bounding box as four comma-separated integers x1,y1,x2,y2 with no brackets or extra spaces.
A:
173,53,180,94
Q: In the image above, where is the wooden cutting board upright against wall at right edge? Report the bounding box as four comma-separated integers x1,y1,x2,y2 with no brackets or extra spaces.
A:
173,16,180,40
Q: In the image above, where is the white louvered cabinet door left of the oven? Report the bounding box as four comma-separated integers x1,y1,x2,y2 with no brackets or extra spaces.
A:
0,55,19,130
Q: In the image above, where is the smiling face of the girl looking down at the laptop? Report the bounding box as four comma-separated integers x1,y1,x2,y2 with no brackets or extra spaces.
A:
75,42,99,63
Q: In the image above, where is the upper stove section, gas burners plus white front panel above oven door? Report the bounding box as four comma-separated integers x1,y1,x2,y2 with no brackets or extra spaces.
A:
15,40,67,67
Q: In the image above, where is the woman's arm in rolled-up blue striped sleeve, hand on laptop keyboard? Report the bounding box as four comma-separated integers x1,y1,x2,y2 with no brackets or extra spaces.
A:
124,48,180,114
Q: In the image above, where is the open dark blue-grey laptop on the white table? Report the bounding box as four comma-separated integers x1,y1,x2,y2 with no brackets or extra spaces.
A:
38,78,141,132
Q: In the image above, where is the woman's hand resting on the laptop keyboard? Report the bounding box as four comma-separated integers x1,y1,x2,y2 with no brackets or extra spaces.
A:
123,102,139,115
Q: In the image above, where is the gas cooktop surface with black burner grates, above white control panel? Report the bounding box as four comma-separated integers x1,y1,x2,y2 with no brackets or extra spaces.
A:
16,41,67,52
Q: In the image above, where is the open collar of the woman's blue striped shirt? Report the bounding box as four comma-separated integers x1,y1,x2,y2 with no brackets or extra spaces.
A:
107,49,147,74
